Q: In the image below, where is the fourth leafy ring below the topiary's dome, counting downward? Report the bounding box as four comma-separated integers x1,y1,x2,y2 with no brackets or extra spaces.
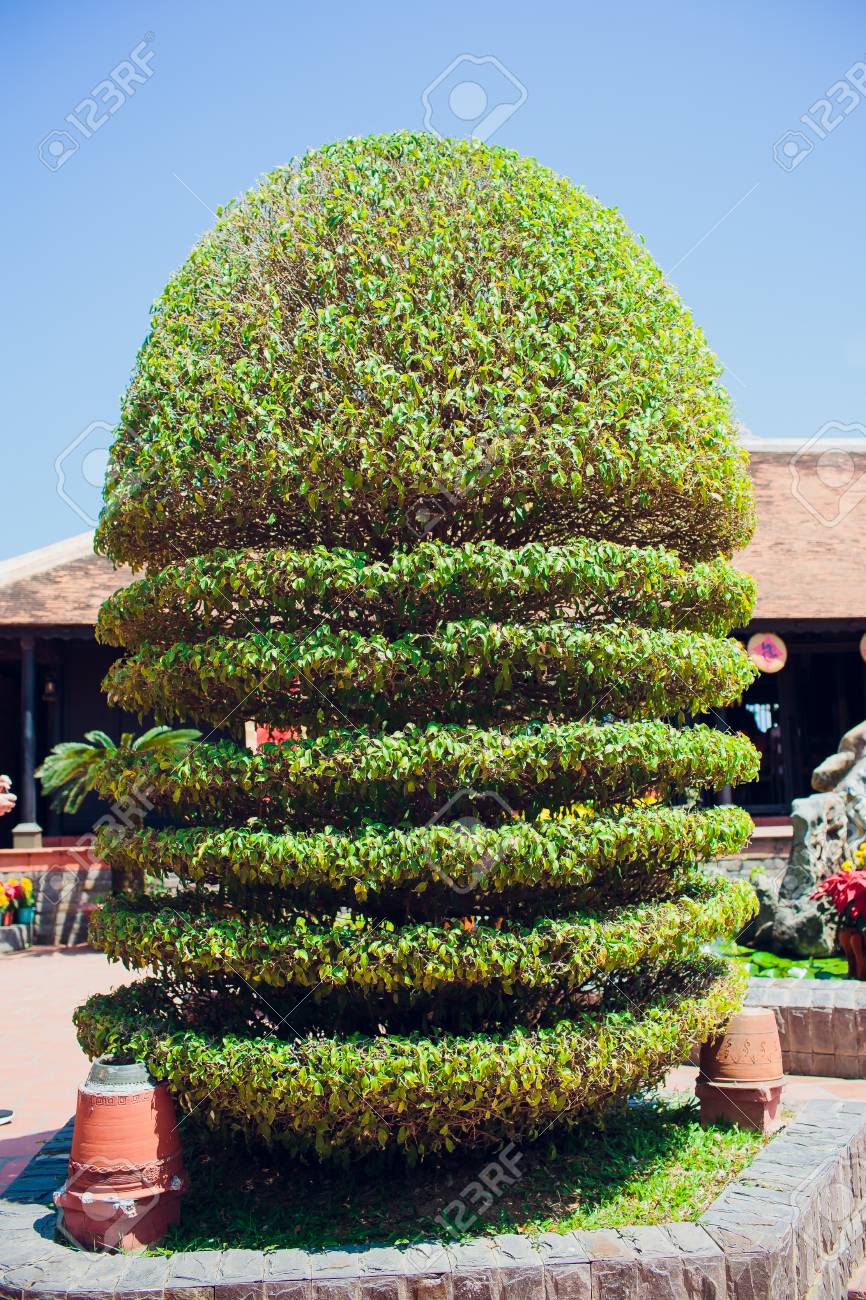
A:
96,806,752,909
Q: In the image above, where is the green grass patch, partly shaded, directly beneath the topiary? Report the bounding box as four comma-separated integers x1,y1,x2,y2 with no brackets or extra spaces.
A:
156,1099,766,1253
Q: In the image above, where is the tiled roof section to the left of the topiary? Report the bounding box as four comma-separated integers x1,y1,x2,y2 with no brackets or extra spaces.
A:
0,533,133,627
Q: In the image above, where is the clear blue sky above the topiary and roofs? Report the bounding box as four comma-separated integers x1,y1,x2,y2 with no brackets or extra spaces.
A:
0,0,866,558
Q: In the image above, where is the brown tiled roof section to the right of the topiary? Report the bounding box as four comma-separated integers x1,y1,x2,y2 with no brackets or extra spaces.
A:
737,439,866,623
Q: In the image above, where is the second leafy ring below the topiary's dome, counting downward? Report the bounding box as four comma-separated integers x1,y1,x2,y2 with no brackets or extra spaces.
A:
105,618,755,729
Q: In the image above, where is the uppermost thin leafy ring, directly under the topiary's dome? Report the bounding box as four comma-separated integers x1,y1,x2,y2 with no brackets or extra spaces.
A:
96,540,754,649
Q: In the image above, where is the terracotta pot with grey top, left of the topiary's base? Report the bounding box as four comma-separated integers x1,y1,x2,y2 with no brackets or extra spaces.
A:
55,1060,187,1251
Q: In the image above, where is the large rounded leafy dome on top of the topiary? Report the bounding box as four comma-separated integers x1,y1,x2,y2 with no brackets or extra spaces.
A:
98,133,752,566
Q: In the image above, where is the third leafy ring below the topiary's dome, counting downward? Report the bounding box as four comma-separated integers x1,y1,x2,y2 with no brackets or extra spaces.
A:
91,720,758,826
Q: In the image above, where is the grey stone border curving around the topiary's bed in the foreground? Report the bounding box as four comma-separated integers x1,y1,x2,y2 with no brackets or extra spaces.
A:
0,1101,866,1300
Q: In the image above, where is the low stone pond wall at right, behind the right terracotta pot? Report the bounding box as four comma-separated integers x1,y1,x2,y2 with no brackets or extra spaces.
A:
745,979,866,1079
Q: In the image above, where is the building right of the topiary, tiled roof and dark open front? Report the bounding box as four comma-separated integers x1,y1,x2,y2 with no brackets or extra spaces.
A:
720,437,866,816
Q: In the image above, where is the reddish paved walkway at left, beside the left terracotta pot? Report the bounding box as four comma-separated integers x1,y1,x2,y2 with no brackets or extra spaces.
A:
0,948,135,1192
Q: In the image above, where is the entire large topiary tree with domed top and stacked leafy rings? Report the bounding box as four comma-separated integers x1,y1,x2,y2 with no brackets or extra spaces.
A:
77,134,755,1156
